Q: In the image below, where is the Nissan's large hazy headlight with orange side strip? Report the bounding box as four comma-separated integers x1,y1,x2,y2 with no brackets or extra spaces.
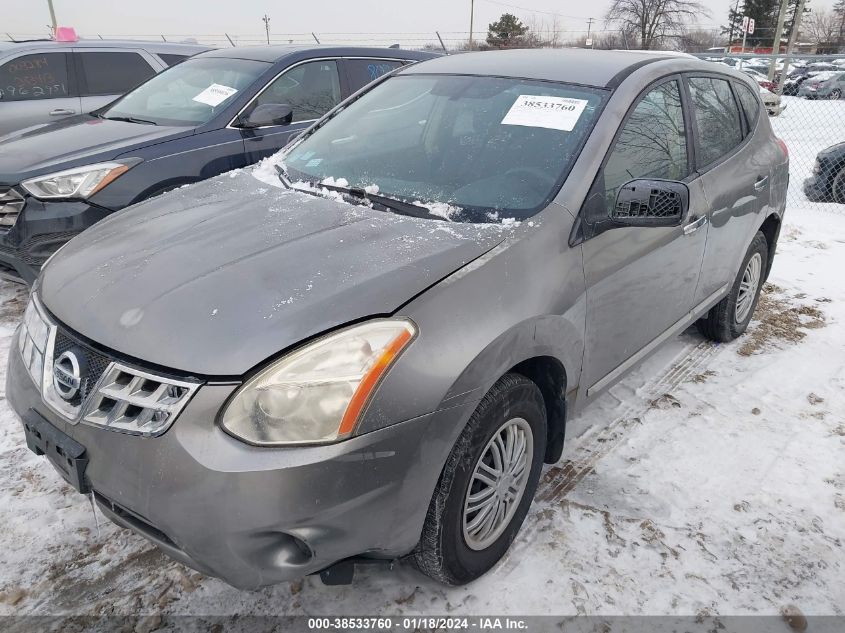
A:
221,319,417,446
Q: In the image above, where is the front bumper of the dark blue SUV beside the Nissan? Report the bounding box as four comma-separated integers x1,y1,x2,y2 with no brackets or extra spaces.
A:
0,196,112,285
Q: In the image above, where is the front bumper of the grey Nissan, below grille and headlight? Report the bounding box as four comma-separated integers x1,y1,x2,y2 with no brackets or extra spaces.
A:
6,341,474,589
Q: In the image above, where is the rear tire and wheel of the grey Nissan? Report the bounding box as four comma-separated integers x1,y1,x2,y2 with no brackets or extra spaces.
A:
696,231,769,343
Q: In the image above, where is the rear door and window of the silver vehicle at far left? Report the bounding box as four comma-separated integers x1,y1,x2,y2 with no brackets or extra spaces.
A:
73,48,164,112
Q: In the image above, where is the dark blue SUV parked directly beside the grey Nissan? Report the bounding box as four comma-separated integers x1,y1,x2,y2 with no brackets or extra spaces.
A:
0,46,436,283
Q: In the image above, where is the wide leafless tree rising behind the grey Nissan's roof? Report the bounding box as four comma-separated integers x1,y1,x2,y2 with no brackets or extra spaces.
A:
605,0,710,50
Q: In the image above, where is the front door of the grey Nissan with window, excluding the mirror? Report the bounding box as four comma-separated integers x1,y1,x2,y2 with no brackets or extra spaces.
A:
581,78,708,396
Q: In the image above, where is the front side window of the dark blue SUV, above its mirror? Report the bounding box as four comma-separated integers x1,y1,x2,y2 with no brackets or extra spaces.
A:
255,60,340,122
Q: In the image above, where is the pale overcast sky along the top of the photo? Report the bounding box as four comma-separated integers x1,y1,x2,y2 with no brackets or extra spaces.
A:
0,0,832,43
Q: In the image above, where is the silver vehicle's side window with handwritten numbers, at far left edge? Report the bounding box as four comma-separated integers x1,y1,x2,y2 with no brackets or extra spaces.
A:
0,53,71,101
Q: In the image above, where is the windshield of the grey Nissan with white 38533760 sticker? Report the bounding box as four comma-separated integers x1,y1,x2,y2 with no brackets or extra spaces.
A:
282,75,606,222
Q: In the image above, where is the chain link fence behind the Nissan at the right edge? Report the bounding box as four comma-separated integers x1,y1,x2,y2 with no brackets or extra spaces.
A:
699,53,845,213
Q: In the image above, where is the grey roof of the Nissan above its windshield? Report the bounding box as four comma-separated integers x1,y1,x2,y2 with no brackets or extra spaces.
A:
402,48,712,87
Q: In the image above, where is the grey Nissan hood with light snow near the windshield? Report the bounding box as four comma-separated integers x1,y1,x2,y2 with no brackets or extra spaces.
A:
40,171,513,376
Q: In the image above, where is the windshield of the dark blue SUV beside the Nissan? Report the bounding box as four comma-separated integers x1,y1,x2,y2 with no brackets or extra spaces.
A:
99,57,269,126
